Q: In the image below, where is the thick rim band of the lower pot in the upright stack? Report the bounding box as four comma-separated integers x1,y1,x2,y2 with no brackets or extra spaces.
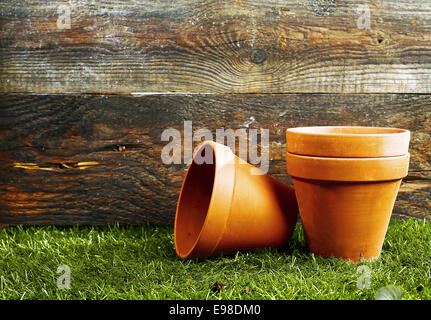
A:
286,152,410,182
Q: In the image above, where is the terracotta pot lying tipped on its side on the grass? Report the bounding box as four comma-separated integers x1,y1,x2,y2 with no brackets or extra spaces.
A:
174,142,298,258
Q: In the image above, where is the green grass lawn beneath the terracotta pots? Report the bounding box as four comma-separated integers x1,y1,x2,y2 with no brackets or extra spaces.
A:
0,218,431,299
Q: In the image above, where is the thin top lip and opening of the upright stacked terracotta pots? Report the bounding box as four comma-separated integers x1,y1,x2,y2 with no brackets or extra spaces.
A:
286,126,410,137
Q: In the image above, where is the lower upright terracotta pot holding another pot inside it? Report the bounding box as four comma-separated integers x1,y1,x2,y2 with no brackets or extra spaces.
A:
286,153,409,262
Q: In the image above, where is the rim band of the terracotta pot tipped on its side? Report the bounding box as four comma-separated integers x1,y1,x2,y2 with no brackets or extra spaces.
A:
174,141,235,259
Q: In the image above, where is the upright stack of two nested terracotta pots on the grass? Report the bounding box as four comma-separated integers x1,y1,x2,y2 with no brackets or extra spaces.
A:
286,127,410,262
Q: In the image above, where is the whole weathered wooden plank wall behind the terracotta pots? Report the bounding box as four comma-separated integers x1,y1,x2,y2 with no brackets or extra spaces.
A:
0,0,431,224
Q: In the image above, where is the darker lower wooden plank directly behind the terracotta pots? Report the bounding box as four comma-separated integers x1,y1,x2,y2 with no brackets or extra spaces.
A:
0,94,431,224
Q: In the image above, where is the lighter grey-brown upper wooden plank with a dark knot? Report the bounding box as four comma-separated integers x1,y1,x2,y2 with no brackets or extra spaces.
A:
0,0,431,94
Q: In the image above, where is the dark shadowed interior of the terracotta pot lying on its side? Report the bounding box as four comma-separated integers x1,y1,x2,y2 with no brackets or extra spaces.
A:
175,145,216,257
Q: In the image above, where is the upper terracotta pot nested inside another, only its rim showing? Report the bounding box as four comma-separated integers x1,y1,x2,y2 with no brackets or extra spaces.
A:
286,127,410,158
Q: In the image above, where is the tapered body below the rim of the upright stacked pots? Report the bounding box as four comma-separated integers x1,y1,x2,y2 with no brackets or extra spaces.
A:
293,177,401,262
